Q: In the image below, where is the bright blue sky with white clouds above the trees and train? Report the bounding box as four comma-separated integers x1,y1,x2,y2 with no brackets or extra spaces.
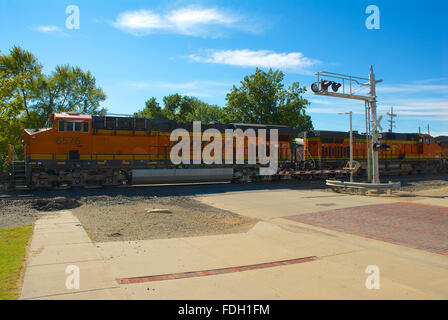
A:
0,0,448,135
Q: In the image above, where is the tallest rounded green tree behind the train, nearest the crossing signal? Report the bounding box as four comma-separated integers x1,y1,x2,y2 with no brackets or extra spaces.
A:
223,68,312,130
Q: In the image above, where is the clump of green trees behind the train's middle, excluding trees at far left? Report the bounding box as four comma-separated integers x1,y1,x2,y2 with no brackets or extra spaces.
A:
134,68,313,131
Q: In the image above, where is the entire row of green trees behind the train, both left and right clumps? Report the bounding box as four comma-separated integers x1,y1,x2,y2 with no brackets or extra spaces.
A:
0,46,312,178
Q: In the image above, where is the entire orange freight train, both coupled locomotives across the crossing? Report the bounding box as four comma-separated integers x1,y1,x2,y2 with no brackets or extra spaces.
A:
9,112,448,189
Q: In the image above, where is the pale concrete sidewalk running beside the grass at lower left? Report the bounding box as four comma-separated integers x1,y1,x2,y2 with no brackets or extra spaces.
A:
20,211,126,299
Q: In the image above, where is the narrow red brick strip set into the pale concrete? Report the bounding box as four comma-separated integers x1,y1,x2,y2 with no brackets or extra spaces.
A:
117,256,317,284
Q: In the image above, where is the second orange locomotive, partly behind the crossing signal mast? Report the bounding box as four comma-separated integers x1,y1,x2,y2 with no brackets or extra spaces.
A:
297,131,447,174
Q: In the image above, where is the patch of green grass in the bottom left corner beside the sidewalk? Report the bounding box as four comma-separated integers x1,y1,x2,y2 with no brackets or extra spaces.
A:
0,225,33,300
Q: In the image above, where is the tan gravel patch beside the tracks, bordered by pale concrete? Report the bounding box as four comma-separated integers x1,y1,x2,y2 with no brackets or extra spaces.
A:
73,196,257,242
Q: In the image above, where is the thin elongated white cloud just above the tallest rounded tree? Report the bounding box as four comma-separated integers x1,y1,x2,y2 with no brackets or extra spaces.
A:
189,49,321,73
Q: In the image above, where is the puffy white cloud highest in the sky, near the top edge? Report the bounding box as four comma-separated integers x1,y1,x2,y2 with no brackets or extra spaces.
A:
113,6,240,37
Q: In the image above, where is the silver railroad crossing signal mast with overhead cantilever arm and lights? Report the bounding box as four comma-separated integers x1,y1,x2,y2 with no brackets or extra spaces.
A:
311,66,382,185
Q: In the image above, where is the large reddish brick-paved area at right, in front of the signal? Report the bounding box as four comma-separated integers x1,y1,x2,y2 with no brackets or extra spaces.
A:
284,202,448,255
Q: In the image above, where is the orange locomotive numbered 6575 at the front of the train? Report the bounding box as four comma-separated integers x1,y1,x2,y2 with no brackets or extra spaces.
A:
15,113,296,188
